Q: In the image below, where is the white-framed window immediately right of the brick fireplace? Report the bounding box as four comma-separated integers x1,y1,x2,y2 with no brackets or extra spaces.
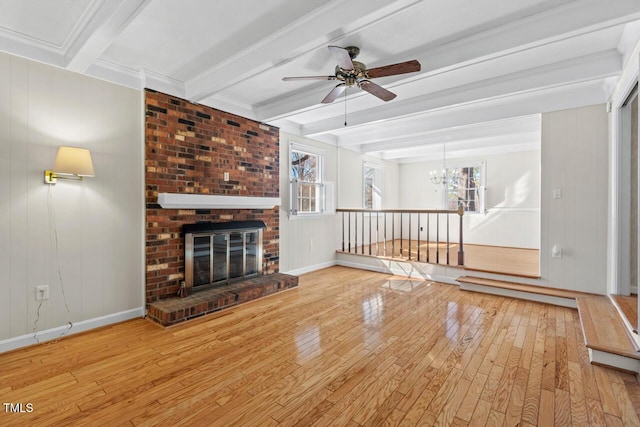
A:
289,143,324,215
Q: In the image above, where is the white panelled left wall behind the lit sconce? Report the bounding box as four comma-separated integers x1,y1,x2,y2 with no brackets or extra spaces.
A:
0,54,144,351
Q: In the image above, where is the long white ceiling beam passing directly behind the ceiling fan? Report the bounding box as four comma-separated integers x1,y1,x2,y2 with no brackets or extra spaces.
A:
254,0,640,121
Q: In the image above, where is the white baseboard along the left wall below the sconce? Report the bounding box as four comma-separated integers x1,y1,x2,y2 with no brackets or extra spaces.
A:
0,307,145,353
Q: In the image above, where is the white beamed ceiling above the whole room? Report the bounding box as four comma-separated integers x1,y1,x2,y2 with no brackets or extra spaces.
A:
0,0,640,162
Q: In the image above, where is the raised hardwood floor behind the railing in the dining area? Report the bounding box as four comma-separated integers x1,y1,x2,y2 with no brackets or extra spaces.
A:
339,239,540,278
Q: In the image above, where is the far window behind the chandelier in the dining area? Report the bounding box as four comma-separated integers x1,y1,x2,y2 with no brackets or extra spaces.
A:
445,163,485,213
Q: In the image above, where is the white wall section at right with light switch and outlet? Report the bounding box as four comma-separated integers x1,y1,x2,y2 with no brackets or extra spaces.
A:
540,105,608,294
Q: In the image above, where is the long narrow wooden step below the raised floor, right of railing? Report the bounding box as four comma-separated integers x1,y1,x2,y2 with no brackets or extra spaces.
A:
456,276,591,308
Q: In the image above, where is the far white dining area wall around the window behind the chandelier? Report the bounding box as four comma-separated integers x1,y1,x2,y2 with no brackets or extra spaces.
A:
399,150,540,249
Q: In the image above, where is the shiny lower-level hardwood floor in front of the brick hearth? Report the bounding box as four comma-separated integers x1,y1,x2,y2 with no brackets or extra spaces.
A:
0,267,640,426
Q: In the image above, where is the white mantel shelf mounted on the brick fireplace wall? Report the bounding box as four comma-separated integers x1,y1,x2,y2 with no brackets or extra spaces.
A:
158,193,280,209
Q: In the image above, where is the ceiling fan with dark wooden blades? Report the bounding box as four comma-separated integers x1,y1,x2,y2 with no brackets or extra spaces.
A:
282,46,420,104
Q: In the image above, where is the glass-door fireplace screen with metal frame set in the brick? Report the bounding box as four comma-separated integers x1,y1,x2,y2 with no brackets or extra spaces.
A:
184,223,264,289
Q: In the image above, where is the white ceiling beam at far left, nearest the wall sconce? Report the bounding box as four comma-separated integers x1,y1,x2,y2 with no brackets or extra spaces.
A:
65,0,151,73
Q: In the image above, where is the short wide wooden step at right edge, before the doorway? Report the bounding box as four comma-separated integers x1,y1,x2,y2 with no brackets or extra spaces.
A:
577,295,640,370
